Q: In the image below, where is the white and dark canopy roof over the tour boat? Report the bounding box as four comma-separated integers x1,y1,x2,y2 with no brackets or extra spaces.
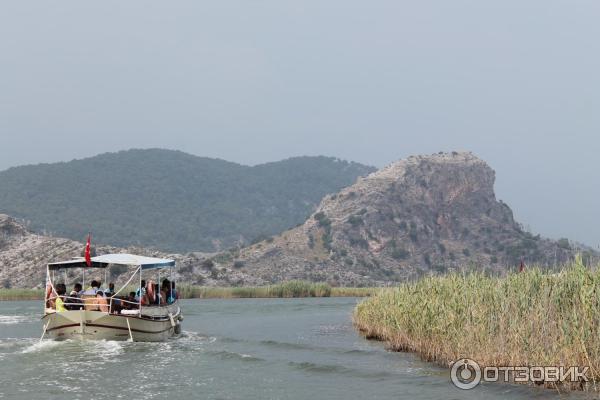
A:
48,254,175,270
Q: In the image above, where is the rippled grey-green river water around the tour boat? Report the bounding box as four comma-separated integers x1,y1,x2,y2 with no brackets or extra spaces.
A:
0,298,587,400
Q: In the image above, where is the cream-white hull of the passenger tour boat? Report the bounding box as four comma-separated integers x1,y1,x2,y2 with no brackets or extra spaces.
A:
42,306,182,342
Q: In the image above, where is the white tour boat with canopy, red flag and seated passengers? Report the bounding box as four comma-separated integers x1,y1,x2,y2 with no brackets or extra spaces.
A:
42,254,183,342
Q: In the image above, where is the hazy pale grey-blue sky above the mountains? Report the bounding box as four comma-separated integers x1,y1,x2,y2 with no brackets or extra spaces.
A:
0,0,600,247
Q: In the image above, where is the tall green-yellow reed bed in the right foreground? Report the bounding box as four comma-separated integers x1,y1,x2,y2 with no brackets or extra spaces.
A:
354,258,600,388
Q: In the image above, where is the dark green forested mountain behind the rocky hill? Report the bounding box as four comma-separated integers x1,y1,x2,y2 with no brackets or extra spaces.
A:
0,149,375,252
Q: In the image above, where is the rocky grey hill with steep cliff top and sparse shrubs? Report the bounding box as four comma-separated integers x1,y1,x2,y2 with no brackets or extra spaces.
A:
227,152,588,285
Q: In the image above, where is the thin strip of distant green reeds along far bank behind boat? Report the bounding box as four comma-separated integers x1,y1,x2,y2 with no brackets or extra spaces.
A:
0,281,380,301
